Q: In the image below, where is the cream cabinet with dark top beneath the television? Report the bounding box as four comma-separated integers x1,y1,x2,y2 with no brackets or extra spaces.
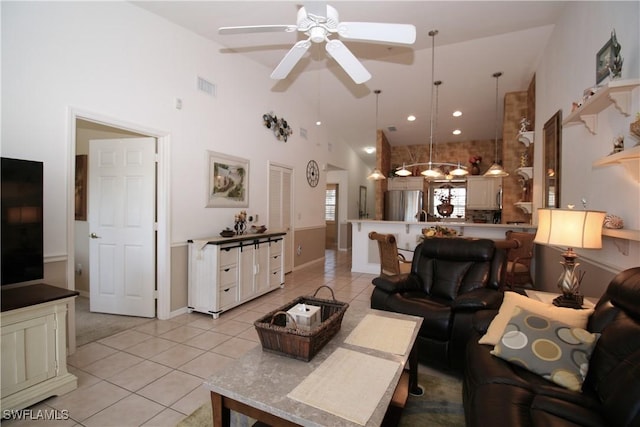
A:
0,284,78,411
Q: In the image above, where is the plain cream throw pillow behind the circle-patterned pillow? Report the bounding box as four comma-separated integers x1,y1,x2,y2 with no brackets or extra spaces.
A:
478,291,593,345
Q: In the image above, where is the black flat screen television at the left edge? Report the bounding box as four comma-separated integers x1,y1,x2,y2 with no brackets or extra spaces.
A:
0,157,44,285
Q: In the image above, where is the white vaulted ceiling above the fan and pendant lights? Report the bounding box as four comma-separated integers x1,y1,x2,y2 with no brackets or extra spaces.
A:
133,1,565,164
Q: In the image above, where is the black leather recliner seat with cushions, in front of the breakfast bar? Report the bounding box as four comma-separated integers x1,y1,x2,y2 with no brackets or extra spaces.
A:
371,238,506,371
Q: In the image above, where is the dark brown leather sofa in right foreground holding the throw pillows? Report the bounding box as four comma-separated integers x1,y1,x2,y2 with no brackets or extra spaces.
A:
463,267,640,427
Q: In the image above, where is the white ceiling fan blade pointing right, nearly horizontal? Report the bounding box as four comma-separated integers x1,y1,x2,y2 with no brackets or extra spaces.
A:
338,22,416,44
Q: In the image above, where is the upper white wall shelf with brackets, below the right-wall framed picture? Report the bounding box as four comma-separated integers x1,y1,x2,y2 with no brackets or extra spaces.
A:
562,79,640,135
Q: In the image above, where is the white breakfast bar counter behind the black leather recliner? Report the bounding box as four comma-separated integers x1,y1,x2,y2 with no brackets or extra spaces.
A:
349,219,536,274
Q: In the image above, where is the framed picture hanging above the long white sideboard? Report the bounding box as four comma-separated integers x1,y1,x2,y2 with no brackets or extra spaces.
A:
207,151,249,208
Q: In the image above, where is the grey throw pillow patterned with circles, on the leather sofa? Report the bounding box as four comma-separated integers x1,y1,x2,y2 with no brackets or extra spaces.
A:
491,307,600,391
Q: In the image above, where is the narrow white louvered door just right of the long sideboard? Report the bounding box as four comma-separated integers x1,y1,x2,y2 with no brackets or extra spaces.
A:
268,165,293,273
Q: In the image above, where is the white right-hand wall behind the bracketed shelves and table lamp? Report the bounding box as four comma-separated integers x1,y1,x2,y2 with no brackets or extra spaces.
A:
534,2,640,283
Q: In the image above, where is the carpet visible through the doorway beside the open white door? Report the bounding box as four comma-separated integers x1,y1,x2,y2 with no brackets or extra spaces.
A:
76,297,151,347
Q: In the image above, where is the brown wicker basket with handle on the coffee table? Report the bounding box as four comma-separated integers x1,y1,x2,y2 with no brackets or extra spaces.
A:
254,286,349,362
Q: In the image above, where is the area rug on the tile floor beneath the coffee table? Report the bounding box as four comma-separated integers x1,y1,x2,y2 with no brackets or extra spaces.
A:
177,365,465,427
